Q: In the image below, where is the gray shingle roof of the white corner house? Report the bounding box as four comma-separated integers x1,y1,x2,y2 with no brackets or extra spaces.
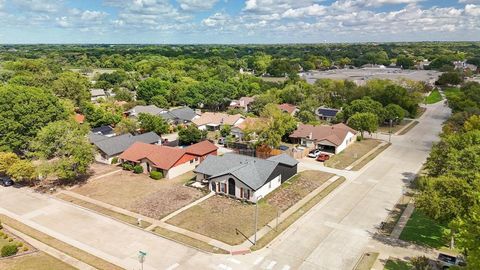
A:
194,154,279,190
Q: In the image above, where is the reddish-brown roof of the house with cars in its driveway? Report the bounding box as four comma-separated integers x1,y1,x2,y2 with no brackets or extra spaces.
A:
290,123,357,146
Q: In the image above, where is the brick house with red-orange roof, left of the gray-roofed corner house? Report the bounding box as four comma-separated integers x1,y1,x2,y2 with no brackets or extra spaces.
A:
119,141,218,179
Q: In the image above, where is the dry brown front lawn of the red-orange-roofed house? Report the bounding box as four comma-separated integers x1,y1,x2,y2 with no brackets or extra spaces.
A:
71,165,205,219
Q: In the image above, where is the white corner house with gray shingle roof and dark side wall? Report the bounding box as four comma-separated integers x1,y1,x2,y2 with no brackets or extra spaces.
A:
194,153,298,202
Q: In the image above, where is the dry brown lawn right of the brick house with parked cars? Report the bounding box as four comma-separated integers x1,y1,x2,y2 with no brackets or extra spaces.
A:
325,139,382,169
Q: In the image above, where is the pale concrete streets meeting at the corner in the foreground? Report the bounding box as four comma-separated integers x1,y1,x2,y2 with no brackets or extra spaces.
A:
0,104,450,270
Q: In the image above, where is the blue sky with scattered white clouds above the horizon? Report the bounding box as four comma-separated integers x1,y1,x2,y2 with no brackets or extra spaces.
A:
0,0,480,44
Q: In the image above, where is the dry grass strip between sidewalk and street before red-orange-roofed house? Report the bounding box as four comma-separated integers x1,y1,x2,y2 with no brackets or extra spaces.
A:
56,194,152,229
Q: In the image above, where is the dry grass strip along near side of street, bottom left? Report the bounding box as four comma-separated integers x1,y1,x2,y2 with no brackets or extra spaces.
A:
0,214,122,270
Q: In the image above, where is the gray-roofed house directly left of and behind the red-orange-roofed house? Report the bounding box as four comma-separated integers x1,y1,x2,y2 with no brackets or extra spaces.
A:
89,132,161,164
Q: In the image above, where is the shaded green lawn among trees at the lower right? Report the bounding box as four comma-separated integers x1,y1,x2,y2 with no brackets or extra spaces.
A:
400,209,448,249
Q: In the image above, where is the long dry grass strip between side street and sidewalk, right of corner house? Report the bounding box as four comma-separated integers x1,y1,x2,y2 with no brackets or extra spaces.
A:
250,177,346,251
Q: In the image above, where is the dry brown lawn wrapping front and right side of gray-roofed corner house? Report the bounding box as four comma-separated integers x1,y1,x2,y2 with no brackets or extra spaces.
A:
167,171,333,245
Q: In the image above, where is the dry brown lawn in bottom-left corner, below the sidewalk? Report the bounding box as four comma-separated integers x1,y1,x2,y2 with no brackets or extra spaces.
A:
0,252,77,270
